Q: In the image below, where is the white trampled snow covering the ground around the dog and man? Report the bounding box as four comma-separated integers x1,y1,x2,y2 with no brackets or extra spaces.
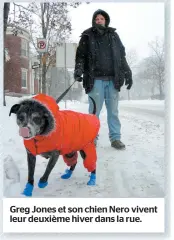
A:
2,97,165,198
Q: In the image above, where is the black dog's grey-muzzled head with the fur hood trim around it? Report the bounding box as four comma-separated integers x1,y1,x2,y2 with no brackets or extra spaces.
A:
9,100,52,139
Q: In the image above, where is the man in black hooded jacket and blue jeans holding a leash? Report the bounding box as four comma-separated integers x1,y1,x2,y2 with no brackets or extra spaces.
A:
74,9,132,149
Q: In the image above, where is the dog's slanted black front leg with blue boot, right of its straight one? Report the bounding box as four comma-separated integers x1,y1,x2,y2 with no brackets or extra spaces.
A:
38,151,59,188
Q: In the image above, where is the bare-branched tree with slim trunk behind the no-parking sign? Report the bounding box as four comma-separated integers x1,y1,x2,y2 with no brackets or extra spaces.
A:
11,2,80,93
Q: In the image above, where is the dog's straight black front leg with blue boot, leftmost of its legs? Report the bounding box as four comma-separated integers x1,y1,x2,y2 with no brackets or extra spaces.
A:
23,151,36,197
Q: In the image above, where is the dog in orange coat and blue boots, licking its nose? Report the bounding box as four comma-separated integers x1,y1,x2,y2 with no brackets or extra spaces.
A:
9,94,100,196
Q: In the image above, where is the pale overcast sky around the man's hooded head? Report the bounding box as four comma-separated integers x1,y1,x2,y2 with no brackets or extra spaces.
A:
69,2,165,58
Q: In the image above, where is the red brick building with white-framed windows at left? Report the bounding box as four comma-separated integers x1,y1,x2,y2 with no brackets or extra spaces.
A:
4,26,32,94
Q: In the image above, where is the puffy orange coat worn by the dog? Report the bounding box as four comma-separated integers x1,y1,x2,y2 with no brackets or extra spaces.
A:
24,94,100,172
